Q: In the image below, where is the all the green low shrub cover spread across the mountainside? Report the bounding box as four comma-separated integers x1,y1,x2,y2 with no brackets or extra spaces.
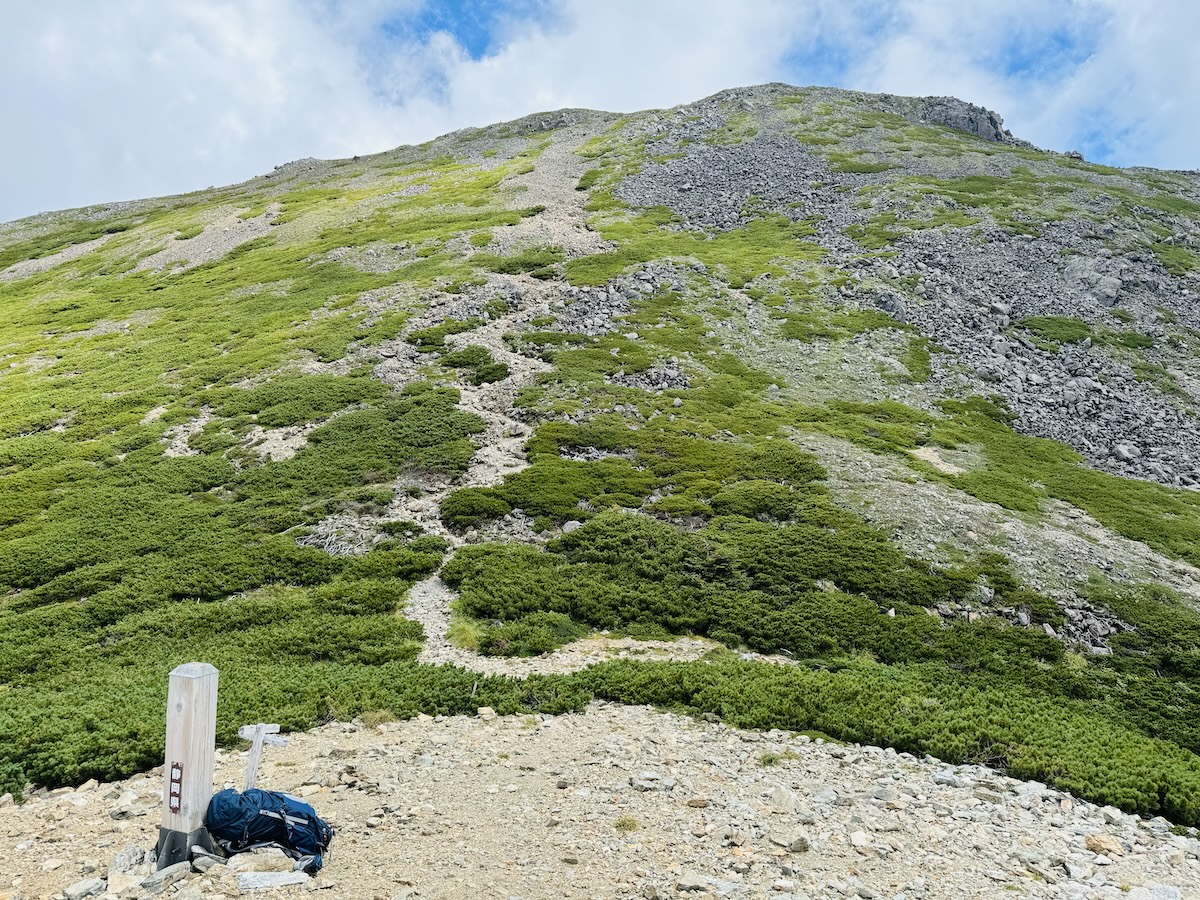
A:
0,112,1200,840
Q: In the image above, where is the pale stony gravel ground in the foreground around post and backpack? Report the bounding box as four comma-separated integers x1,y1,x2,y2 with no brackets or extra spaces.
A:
0,703,1200,900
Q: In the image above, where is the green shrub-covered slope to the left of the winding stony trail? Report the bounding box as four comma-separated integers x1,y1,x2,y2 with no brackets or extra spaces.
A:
0,133,566,788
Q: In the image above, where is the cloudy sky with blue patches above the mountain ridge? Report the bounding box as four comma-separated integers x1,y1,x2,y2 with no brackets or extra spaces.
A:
0,0,1200,221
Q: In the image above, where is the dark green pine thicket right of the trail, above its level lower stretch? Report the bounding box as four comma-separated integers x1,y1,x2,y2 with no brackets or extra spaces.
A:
442,504,1200,763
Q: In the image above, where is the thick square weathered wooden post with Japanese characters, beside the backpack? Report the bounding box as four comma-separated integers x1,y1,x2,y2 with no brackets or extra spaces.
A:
158,662,217,869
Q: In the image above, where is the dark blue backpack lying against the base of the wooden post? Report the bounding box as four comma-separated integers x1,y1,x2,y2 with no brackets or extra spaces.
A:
204,787,334,874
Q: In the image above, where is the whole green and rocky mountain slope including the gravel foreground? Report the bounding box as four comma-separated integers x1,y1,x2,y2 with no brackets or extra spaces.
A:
0,84,1200,900
